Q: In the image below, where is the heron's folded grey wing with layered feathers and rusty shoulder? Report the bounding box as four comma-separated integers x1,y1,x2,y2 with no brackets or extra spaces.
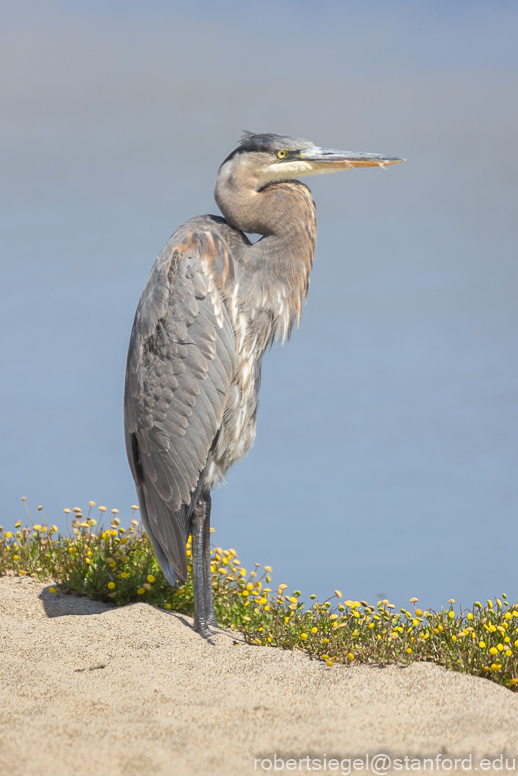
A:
125,229,235,582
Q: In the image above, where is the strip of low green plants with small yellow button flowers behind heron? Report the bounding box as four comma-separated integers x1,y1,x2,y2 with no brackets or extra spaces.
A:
0,499,518,690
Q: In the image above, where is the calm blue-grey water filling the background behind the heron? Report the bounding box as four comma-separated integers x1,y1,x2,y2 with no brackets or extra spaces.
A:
0,2,518,606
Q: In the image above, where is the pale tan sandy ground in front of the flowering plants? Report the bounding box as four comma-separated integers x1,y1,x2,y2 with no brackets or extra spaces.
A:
0,577,518,776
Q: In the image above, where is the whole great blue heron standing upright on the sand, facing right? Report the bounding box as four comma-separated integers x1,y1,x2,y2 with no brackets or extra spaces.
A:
125,132,402,638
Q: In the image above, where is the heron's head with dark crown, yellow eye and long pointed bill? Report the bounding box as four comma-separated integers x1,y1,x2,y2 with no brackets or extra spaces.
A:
218,132,403,190
